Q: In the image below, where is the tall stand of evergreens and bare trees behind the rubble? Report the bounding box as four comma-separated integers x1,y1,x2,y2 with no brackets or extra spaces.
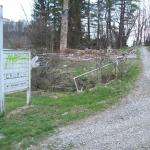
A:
4,0,148,52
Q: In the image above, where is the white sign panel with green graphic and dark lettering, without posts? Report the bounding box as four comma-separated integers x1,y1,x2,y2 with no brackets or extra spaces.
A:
3,50,31,94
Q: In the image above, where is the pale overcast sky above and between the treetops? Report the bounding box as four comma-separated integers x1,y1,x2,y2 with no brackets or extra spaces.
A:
0,0,150,21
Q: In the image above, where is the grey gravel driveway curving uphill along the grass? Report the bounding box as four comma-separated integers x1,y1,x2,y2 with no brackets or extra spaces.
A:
30,47,150,150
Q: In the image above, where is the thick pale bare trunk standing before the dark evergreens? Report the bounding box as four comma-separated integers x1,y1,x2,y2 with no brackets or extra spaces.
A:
60,0,69,52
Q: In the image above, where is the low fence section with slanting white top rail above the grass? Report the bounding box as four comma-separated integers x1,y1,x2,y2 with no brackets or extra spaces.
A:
73,57,126,92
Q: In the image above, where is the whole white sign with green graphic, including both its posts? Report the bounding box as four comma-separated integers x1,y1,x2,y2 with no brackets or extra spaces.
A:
0,5,31,113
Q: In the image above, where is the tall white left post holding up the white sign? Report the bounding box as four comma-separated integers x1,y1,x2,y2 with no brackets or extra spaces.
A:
0,5,4,113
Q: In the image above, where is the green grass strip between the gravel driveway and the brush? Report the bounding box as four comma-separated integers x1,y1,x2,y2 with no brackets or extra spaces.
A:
0,60,140,150
